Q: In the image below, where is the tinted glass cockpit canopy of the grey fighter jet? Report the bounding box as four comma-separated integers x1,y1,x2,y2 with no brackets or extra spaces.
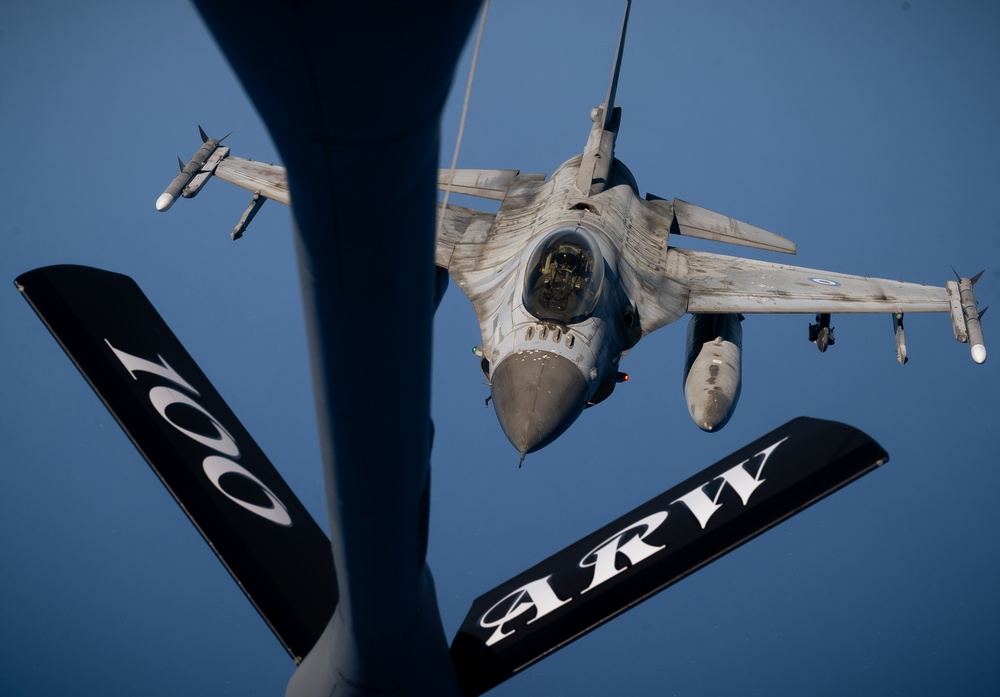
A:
524,227,604,324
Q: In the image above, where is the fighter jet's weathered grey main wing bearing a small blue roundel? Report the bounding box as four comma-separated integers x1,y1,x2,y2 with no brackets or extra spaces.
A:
667,248,951,314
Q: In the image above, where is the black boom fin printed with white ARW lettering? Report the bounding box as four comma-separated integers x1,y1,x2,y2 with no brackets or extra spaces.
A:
451,417,888,697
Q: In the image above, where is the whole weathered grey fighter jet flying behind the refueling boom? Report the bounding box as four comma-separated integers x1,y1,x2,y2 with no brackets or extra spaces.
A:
156,2,986,460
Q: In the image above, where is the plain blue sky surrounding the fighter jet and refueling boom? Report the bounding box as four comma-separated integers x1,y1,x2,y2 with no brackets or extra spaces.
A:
0,0,1000,696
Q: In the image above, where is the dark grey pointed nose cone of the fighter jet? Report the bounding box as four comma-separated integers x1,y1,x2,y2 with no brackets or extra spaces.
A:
491,351,587,454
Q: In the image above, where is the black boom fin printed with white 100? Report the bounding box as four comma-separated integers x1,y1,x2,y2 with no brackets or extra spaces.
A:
15,266,337,662
